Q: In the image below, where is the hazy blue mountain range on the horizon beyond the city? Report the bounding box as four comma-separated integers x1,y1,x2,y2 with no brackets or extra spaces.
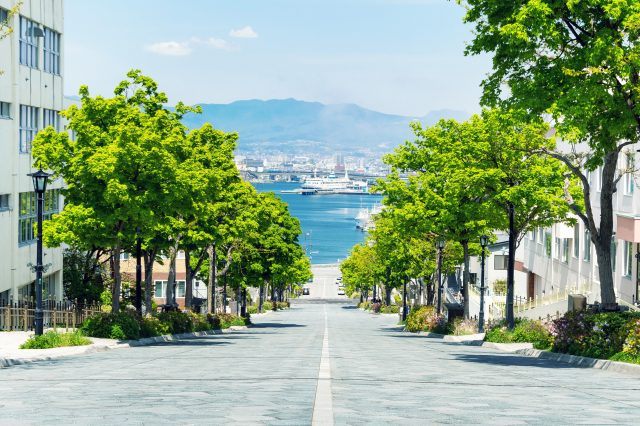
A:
183,99,469,154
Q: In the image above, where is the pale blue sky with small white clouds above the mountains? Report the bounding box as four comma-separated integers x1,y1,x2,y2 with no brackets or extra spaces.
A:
65,0,490,116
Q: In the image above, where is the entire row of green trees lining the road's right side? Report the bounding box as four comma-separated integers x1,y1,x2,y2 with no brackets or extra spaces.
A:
343,0,640,324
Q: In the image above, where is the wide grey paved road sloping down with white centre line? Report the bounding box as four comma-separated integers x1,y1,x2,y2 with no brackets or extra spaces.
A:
0,303,640,425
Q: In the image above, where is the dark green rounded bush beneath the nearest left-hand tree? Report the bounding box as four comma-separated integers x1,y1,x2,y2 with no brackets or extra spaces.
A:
80,312,140,340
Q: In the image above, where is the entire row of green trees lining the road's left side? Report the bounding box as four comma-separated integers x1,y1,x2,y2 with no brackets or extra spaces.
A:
33,70,310,312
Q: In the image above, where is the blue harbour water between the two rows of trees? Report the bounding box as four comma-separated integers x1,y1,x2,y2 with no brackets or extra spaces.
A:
254,183,382,264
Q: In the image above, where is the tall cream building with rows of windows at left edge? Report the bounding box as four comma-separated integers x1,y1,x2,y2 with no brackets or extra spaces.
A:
0,0,64,302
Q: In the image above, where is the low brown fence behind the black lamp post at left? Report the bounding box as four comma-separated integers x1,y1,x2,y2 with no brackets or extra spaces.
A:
0,300,101,331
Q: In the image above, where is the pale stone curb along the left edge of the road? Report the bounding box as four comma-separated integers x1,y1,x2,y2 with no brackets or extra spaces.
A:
0,325,248,368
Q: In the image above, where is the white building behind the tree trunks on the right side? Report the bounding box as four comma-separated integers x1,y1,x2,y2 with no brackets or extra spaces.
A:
470,150,640,309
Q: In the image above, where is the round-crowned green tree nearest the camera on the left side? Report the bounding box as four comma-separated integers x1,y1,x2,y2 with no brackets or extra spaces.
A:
33,70,192,311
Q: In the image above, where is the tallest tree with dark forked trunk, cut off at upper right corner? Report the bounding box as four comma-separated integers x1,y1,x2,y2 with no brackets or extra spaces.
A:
459,0,640,305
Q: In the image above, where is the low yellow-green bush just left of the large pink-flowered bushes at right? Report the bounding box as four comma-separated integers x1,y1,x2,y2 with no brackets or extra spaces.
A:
484,319,553,349
